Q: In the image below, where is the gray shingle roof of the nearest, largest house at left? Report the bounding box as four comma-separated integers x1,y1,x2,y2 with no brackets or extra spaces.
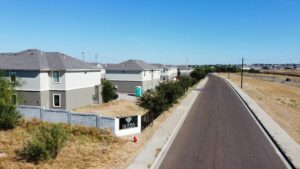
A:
0,49,100,71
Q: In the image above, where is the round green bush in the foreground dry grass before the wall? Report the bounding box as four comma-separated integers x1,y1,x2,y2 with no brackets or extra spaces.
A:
20,123,70,163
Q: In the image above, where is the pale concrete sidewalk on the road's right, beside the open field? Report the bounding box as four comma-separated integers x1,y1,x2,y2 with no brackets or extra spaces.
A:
223,76,300,168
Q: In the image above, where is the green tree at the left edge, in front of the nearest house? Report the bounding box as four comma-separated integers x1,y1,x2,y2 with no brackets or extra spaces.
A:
0,72,22,129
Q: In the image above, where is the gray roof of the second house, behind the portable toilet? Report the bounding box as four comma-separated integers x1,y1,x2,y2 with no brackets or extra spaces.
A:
104,59,160,71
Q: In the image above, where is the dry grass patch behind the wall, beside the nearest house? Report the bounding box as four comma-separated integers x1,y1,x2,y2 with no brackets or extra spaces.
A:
73,100,146,117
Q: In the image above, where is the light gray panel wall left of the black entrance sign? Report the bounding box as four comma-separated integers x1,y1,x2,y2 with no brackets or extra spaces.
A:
17,105,115,133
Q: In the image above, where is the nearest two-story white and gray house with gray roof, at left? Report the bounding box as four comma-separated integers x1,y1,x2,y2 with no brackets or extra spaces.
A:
0,49,101,110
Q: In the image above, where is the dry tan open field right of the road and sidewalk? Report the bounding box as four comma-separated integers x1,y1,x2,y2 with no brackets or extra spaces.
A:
221,74,300,144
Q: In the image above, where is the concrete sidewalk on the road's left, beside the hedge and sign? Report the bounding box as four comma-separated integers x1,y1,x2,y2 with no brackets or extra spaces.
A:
127,78,207,169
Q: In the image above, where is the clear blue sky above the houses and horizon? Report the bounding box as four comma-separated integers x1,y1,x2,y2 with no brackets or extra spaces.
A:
0,0,300,64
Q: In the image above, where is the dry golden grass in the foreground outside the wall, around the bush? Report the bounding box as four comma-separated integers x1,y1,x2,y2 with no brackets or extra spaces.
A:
0,121,132,169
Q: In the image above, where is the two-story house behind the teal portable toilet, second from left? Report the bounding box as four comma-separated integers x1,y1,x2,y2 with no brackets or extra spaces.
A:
104,59,161,93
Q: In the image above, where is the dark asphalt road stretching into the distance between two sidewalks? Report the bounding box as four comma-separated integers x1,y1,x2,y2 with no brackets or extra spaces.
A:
160,75,286,169
